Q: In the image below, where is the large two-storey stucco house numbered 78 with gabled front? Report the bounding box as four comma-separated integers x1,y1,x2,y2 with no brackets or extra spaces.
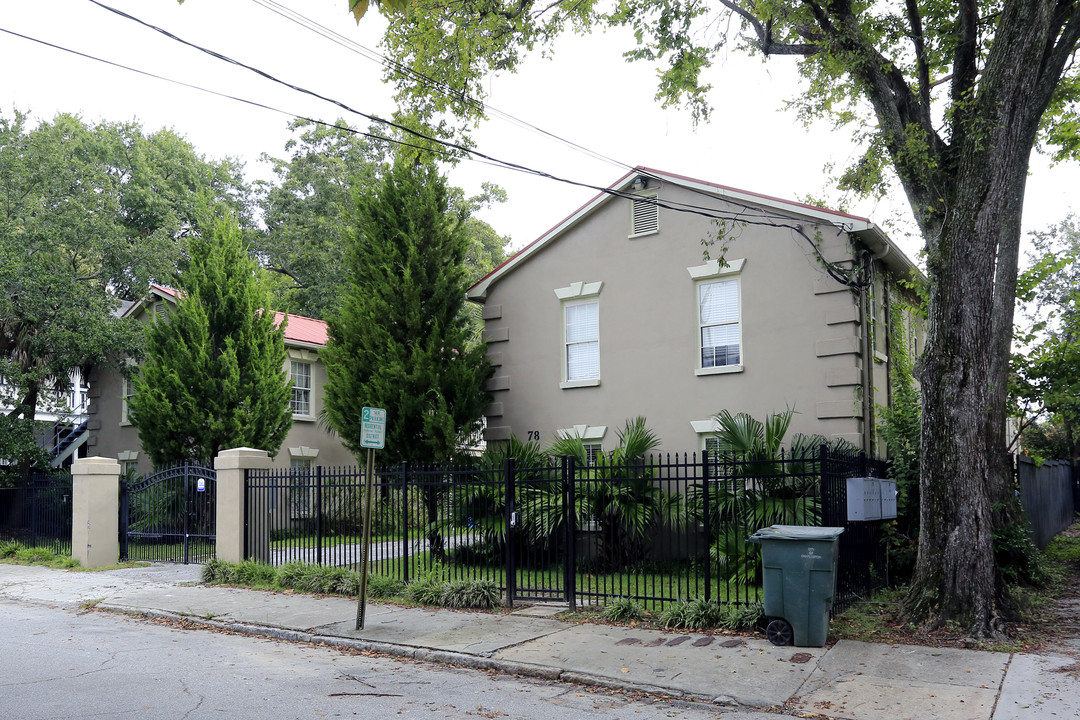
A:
468,167,923,454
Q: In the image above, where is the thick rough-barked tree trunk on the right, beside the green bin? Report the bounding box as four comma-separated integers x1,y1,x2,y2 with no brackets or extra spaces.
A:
905,2,1054,637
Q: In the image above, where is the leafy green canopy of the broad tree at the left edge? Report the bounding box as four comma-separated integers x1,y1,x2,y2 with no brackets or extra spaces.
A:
0,111,246,466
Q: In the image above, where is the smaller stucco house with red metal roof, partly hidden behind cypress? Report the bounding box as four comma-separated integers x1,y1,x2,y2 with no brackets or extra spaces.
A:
87,285,356,474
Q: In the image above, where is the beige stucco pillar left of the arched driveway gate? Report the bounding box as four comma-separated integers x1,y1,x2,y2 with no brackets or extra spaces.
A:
71,458,120,568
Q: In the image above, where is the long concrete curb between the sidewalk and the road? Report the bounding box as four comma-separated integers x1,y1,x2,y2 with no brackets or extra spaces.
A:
95,602,734,709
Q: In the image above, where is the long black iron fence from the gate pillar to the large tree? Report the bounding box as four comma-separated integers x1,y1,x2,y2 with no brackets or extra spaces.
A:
245,448,887,609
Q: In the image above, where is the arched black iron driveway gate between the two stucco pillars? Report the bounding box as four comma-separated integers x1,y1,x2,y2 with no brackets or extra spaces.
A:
120,463,217,565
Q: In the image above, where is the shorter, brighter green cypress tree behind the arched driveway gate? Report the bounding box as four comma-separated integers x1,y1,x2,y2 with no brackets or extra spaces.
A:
129,213,293,464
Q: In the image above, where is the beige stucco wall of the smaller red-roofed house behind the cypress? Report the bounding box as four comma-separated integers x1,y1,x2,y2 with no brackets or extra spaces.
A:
87,347,359,474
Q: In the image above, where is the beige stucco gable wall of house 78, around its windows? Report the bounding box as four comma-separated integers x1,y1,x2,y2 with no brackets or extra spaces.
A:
485,185,863,451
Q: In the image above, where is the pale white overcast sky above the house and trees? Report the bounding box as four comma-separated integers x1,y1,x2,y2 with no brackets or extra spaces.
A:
0,0,1080,264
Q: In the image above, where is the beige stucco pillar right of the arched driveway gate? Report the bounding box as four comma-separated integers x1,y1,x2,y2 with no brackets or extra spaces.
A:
214,448,270,562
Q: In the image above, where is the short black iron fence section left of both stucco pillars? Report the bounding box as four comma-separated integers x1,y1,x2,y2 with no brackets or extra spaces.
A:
0,473,71,555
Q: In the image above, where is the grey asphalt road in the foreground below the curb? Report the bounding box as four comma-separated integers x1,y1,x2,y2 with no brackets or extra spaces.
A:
0,600,777,720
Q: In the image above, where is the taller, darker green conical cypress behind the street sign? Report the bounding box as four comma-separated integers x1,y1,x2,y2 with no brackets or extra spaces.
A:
323,162,490,461
